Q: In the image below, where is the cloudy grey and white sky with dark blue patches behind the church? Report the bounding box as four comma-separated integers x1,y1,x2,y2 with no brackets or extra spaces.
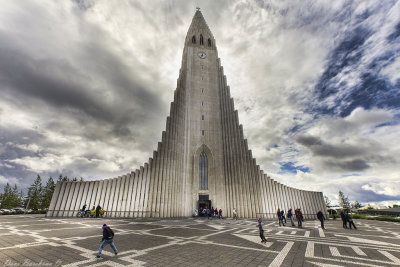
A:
0,0,400,204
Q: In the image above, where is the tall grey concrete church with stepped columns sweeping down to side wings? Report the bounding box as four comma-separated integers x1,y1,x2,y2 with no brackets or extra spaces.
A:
47,10,326,218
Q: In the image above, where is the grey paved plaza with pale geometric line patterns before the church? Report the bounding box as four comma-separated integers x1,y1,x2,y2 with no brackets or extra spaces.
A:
0,215,400,266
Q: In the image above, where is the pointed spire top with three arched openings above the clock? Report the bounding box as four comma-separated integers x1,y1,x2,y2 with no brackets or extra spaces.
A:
186,7,215,49
